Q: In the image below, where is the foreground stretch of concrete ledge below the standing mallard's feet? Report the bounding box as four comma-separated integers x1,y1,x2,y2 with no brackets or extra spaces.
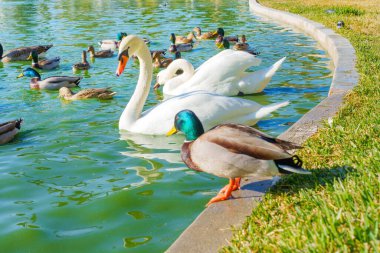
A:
167,179,272,253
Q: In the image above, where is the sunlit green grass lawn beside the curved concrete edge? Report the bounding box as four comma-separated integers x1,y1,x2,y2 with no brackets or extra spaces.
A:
222,0,380,252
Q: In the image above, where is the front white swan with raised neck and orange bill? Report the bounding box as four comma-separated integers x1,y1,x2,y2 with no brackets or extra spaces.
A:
116,35,289,135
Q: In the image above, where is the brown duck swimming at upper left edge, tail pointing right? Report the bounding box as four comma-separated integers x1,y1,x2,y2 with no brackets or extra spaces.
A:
0,44,53,62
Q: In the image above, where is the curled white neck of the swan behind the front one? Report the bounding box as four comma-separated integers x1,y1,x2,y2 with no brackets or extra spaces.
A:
164,59,195,91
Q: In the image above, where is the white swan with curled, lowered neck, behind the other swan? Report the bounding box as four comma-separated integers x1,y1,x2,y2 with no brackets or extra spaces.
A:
154,49,286,96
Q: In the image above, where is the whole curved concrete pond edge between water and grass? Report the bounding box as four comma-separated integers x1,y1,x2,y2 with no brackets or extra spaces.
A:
166,0,359,253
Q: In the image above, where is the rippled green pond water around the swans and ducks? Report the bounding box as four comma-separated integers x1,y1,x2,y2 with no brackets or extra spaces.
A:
0,0,331,253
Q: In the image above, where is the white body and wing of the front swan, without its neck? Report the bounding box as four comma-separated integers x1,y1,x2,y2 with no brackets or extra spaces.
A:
127,91,285,134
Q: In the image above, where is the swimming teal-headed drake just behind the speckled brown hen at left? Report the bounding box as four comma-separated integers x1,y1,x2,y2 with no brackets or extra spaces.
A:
17,68,81,90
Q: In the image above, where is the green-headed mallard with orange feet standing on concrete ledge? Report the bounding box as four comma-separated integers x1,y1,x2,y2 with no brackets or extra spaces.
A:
167,110,311,205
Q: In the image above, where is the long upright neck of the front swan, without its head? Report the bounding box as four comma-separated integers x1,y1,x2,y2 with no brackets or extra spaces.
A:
119,42,153,129
